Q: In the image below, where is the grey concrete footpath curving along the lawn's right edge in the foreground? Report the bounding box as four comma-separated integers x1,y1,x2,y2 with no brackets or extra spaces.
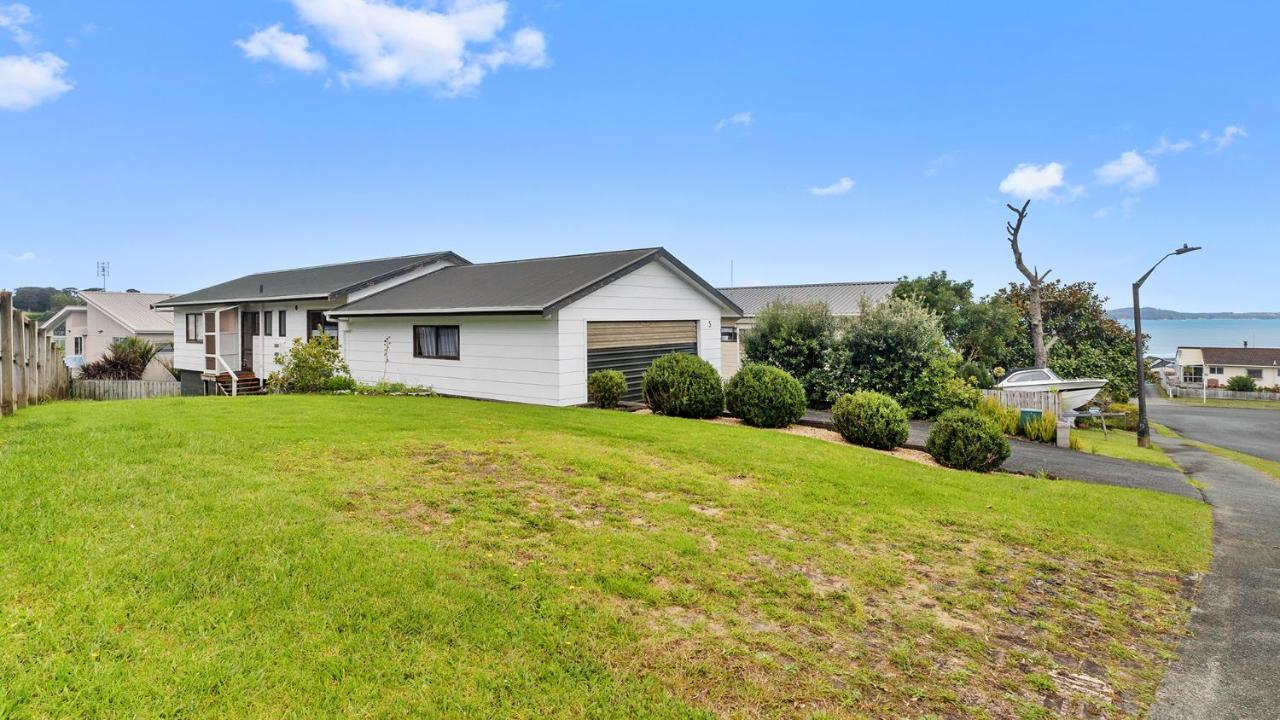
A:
1151,435,1280,720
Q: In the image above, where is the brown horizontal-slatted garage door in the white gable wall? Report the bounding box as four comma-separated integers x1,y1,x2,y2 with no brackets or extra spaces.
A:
586,320,698,400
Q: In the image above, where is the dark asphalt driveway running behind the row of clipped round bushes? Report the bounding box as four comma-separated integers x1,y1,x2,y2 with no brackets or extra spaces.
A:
801,410,1201,500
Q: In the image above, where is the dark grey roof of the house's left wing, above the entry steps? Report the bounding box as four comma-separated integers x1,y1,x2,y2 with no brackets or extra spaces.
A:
155,251,466,307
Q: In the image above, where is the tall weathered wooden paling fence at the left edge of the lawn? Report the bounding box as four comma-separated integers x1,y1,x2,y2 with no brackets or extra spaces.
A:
0,290,70,415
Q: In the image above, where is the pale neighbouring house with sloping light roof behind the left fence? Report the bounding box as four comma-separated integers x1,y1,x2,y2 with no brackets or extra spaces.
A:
42,291,173,380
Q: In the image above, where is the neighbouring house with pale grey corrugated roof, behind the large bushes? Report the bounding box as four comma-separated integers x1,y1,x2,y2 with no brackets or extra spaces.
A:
719,281,897,378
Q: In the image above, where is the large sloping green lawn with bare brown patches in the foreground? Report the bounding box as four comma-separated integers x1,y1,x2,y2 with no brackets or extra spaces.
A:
0,396,1211,717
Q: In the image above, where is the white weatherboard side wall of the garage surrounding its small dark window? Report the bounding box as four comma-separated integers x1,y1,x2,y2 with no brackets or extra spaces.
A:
343,315,565,405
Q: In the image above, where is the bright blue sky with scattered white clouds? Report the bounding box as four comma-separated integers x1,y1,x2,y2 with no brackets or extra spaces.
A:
0,0,1280,310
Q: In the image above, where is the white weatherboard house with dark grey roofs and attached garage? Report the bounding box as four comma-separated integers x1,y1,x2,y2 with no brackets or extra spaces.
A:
159,247,740,405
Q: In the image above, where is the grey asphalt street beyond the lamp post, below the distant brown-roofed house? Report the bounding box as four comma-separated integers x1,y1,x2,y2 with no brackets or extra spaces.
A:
1147,396,1280,458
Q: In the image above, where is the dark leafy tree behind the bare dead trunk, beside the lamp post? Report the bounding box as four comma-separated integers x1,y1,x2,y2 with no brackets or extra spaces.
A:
993,281,1138,400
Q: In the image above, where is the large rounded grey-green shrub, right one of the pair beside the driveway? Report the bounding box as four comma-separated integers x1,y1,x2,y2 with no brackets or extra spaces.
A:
833,297,957,418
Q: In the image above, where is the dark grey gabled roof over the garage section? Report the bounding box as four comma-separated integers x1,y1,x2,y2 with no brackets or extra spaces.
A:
330,247,739,316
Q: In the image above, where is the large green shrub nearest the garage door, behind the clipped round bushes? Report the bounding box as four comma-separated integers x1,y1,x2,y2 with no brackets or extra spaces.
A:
742,301,837,405
